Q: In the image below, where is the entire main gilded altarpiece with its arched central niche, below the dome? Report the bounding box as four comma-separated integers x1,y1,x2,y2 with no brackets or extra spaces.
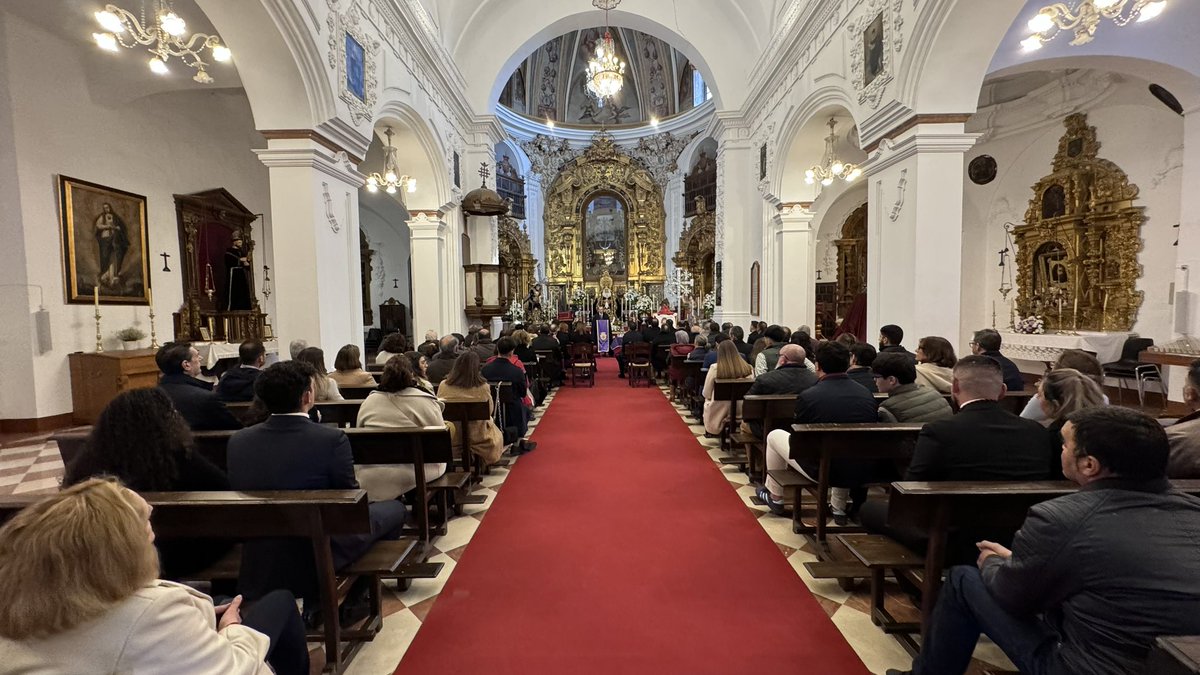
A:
545,132,666,305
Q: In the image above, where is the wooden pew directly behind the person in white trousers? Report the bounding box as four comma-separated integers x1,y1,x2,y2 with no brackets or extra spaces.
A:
772,423,924,550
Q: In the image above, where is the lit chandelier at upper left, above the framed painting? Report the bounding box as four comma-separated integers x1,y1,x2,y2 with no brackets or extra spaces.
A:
91,0,232,84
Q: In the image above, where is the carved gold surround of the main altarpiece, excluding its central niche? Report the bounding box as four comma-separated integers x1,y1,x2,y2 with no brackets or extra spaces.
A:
545,131,666,289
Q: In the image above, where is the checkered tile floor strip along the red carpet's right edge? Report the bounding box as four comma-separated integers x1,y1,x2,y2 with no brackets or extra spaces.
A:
660,386,1016,675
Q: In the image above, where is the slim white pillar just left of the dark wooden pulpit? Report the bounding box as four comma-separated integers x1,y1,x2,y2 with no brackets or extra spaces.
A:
408,211,451,335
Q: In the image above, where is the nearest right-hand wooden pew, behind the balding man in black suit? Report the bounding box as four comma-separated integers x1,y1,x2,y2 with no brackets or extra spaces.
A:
888,480,1200,643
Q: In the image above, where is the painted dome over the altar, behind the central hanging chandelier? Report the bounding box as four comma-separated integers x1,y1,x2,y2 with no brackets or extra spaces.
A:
499,28,710,126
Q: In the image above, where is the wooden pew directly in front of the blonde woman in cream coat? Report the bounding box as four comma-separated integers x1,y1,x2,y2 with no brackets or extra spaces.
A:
0,490,416,675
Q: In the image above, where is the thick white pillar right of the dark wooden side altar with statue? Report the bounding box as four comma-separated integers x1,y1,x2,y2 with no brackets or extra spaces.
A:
254,138,364,364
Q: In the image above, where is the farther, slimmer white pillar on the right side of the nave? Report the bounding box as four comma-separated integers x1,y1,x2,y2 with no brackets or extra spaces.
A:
763,202,816,330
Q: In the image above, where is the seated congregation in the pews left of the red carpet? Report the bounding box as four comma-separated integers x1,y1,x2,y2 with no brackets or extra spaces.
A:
0,330,547,675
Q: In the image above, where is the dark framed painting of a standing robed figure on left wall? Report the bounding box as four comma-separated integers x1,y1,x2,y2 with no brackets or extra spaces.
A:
59,175,150,305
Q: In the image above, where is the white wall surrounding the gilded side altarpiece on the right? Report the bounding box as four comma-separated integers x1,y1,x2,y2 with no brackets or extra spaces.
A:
958,78,1183,355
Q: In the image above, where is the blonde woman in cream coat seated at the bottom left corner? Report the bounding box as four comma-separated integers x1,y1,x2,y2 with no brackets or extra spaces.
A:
0,478,308,675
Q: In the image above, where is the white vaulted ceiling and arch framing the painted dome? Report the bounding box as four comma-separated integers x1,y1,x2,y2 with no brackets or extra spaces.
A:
426,0,794,110
